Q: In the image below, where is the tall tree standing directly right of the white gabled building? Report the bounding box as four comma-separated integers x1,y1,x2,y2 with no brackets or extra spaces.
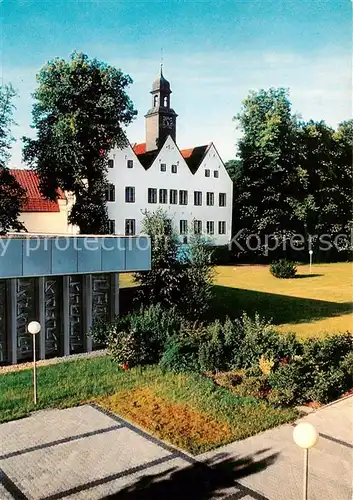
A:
233,88,298,258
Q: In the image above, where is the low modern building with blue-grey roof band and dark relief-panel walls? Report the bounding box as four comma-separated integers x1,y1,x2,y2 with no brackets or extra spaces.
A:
0,233,151,364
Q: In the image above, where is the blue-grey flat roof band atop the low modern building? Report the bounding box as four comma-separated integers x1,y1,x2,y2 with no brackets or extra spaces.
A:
0,233,151,279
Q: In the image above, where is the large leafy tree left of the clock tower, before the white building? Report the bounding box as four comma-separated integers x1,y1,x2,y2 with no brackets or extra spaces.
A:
23,52,137,234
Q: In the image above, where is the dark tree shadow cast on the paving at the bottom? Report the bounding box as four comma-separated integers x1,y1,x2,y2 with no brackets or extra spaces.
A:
102,449,278,500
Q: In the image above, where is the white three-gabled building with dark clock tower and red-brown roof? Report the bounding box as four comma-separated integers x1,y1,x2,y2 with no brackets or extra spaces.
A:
107,69,233,245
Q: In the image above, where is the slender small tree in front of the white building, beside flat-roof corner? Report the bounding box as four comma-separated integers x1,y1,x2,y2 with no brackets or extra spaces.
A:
134,209,213,318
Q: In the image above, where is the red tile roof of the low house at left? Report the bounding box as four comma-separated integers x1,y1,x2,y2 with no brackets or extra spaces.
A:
11,169,65,212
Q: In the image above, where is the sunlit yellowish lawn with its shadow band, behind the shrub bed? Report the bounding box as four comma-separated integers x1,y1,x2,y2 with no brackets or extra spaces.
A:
121,263,353,338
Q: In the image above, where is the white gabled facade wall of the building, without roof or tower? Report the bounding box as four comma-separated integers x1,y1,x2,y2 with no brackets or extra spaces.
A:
107,136,233,245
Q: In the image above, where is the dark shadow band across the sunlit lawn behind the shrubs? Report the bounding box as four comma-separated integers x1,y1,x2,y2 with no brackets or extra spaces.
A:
208,286,352,325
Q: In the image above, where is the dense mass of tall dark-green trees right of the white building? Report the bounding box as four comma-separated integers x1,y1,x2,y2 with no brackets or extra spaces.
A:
226,88,353,258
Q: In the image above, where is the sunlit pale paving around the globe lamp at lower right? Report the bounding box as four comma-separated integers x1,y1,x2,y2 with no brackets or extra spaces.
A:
198,398,353,500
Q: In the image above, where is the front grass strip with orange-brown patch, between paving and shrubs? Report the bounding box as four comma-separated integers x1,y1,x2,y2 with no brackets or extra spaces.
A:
0,356,297,453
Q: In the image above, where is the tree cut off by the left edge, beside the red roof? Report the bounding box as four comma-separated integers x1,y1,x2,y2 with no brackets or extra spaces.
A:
0,85,25,234
